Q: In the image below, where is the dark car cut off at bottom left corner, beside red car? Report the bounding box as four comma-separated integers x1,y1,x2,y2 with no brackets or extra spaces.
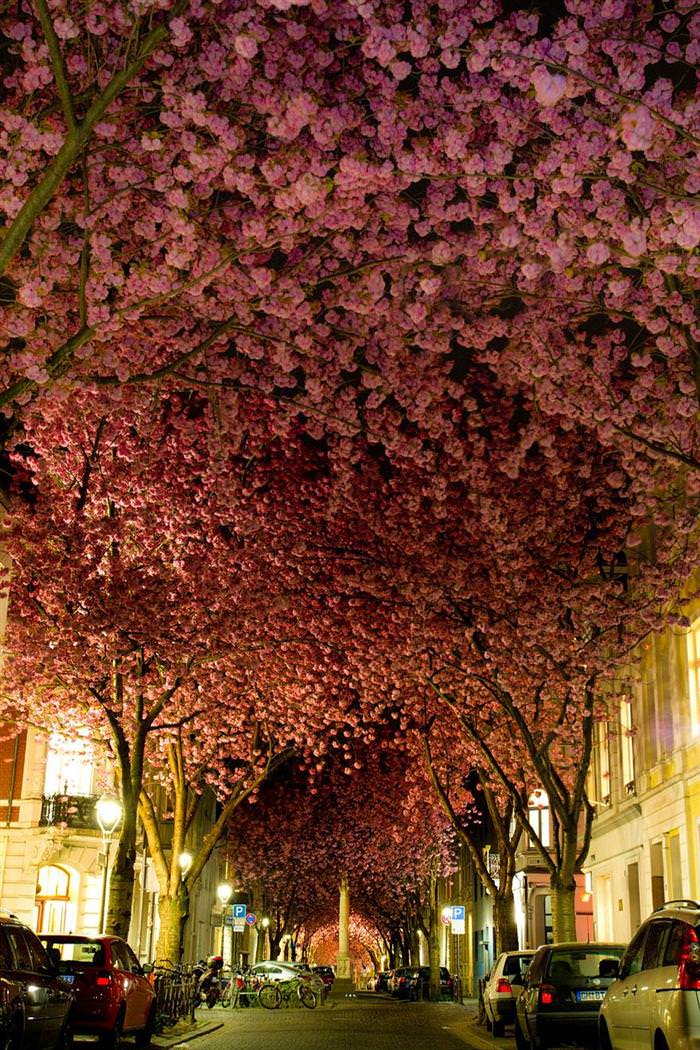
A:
0,912,72,1050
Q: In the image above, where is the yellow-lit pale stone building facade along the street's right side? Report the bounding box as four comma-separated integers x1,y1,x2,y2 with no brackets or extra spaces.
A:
587,610,700,941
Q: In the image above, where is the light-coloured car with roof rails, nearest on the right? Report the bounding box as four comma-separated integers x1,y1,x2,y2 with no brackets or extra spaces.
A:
599,901,700,1050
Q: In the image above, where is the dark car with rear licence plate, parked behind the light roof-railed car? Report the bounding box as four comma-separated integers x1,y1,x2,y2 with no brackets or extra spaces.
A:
515,941,625,1050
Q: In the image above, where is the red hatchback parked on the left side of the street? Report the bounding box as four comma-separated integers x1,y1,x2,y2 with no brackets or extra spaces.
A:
40,933,155,1050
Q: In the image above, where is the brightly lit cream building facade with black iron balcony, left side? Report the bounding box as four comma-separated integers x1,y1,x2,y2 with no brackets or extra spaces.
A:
0,727,228,962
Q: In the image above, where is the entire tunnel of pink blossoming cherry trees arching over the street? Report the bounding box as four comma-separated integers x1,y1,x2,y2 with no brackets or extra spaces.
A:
0,0,700,965
